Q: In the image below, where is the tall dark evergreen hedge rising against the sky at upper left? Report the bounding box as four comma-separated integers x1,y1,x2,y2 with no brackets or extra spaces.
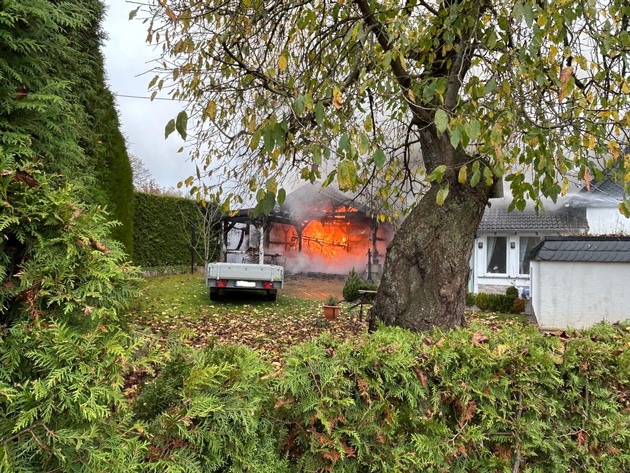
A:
0,0,133,254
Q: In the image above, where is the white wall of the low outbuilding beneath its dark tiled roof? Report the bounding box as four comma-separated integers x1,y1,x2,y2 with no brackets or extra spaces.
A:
531,261,630,330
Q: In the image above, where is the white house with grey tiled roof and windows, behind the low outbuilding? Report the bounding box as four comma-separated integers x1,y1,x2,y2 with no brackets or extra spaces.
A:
469,179,630,293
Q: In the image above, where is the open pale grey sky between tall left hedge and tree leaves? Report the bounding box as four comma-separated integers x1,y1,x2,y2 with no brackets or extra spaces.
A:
103,0,194,187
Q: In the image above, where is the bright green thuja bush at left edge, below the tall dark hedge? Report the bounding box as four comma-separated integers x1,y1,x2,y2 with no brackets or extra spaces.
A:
0,154,144,472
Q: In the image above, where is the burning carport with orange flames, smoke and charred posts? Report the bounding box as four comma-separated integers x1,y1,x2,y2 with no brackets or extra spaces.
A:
224,184,393,279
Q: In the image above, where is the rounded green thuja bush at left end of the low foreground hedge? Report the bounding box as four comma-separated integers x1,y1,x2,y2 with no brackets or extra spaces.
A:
134,346,289,473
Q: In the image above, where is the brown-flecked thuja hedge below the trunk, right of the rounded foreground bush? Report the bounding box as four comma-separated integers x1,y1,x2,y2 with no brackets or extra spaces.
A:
276,326,630,472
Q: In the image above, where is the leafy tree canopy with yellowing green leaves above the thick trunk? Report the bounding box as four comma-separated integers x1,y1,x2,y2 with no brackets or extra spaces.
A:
143,0,630,215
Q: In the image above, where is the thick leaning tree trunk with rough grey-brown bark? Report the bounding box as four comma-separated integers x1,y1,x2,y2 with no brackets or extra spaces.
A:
370,176,490,331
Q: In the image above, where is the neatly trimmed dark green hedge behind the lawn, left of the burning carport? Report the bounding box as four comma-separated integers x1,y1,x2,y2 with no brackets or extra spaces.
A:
133,192,218,267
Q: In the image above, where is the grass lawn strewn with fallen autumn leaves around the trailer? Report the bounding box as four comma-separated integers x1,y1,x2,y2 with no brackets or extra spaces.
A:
130,275,526,363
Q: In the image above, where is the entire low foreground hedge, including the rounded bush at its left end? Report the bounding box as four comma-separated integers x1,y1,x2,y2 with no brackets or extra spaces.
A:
135,326,630,473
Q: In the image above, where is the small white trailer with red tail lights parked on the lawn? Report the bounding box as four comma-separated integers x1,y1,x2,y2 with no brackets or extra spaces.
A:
206,263,284,301
